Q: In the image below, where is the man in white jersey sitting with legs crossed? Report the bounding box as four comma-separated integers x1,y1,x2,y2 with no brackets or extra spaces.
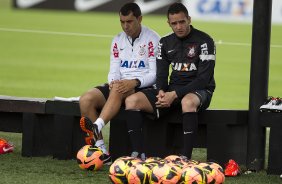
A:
79,3,160,163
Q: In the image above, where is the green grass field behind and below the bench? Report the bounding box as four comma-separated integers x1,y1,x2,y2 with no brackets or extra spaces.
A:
0,0,282,184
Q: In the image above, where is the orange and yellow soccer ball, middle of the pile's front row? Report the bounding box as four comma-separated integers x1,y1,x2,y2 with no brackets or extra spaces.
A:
150,164,180,184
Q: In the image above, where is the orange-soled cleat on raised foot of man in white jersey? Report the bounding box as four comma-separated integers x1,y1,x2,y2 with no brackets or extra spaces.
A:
80,117,97,145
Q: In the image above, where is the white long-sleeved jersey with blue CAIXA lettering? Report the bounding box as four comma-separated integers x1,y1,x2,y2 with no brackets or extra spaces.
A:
108,26,160,88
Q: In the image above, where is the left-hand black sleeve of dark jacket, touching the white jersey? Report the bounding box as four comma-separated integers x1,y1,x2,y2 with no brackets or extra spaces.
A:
156,39,170,91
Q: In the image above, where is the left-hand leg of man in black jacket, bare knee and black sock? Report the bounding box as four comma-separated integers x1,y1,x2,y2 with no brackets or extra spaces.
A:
125,89,156,160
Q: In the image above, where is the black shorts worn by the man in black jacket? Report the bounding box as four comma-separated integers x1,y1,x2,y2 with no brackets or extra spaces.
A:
141,89,213,119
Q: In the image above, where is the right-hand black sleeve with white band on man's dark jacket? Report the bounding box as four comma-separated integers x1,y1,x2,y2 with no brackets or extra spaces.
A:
176,40,216,98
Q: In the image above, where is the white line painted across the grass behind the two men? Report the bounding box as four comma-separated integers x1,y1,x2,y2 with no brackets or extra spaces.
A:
0,27,282,48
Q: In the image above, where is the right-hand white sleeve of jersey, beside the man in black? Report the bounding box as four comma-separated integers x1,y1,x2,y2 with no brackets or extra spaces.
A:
138,35,159,88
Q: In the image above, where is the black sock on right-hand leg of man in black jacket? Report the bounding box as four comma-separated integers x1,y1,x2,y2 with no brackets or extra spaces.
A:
182,112,198,159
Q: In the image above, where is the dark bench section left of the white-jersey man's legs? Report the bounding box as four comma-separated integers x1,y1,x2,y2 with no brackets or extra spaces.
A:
0,96,84,159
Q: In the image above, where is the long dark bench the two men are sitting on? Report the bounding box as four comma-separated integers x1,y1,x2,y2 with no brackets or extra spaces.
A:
0,96,248,165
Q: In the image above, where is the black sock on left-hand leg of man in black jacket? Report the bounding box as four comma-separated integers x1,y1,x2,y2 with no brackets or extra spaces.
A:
126,110,144,154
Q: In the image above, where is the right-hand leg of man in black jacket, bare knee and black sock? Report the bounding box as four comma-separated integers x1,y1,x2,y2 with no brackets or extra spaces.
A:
181,90,210,159
